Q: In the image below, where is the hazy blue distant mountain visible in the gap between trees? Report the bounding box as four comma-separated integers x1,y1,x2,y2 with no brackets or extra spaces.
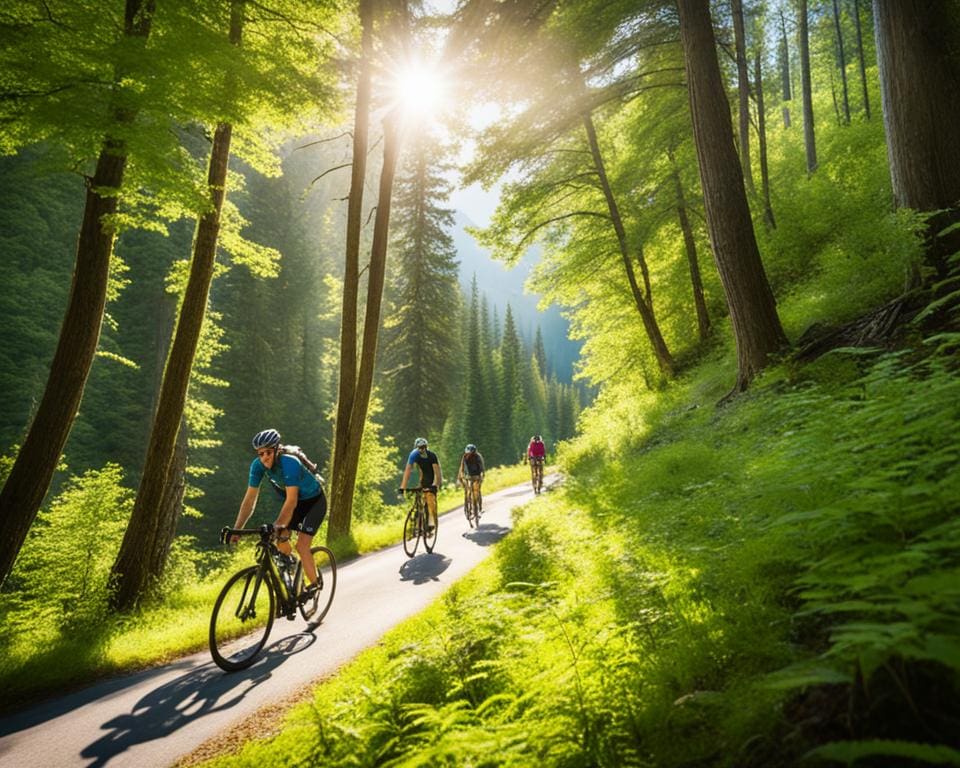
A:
451,211,580,383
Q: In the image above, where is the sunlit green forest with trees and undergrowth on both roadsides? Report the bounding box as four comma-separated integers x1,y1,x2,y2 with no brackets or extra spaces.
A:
0,0,960,768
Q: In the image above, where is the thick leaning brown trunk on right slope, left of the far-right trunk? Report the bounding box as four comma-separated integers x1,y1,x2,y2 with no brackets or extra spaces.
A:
677,0,787,392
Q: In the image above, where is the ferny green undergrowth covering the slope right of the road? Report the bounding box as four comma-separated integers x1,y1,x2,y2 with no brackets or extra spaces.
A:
197,334,960,768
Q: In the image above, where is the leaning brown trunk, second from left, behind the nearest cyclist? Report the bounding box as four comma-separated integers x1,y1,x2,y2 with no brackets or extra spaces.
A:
110,0,244,610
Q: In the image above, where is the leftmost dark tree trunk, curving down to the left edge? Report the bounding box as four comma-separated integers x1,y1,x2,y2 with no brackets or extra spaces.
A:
0,0,154,584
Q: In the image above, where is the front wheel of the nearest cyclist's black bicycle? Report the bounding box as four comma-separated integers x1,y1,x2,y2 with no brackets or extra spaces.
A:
210,565,274,672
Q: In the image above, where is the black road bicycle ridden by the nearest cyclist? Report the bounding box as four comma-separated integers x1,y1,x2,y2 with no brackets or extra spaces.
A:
210,525,337,672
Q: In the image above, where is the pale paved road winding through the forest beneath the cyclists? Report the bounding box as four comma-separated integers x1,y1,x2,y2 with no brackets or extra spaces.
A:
0,478,552,768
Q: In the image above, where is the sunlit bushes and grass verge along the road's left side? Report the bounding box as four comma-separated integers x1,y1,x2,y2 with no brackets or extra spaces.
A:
0,464,529,712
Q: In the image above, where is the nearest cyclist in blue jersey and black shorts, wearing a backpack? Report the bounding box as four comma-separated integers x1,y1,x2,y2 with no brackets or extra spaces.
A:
231,429,327,594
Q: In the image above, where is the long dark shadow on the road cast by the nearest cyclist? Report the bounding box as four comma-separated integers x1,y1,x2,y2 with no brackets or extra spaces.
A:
80,631,316,768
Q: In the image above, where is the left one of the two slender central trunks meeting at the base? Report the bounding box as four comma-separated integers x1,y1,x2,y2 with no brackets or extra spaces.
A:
327,0,373,541
